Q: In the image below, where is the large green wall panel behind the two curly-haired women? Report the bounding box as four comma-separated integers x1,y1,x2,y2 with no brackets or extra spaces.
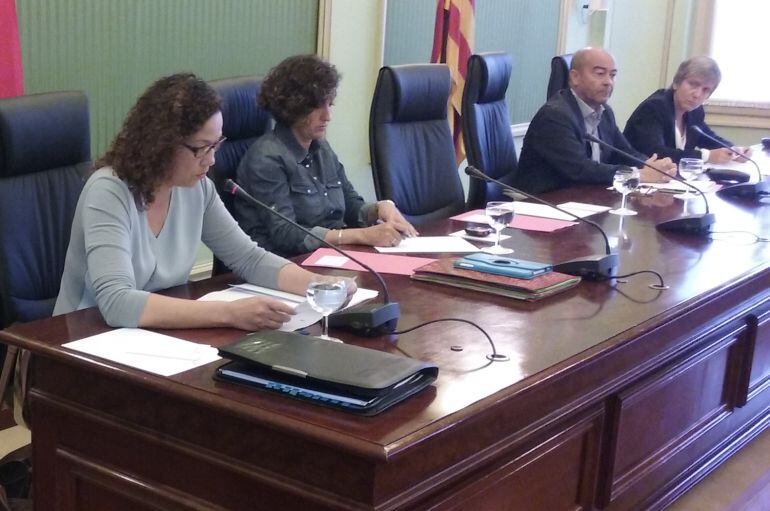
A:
16,0,318,158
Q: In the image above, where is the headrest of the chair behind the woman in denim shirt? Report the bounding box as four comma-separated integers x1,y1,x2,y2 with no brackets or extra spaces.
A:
208,76,270,140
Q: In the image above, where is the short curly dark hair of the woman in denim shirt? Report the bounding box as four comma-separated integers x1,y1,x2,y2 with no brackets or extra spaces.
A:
257,55,340,126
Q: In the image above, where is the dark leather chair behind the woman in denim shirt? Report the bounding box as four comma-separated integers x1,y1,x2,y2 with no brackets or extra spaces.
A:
208,76,272,275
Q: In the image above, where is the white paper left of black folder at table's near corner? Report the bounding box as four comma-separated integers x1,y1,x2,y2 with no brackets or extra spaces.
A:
62,328,220,376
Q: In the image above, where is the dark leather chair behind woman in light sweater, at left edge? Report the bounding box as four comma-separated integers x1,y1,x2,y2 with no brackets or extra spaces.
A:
0,92,91,326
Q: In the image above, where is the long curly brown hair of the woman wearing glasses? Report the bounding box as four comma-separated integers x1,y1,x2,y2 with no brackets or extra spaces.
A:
94,73,221,207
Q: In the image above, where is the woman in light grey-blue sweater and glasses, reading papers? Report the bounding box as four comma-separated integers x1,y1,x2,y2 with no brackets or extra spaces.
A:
54,73,355,330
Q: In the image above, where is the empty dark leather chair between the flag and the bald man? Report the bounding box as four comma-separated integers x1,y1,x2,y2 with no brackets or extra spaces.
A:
462,52,518,209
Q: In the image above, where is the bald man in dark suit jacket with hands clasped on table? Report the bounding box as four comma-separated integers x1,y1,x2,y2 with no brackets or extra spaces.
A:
515,48,676,193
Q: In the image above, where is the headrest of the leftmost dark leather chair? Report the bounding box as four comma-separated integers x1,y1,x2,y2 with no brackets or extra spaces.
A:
0,92,91,178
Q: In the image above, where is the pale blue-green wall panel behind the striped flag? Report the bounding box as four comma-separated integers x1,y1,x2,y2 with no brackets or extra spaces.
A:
385,0,561,123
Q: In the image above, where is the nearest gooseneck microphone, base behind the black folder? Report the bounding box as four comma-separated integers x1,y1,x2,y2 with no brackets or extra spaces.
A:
224,179,401,337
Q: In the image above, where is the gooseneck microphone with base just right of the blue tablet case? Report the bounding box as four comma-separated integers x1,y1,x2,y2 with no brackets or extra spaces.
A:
465,165,618,280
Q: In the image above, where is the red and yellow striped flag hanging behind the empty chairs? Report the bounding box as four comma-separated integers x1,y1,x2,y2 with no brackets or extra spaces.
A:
430,0,476,164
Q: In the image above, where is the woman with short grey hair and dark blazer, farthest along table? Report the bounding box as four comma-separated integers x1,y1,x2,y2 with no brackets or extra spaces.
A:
623,56,751,163
